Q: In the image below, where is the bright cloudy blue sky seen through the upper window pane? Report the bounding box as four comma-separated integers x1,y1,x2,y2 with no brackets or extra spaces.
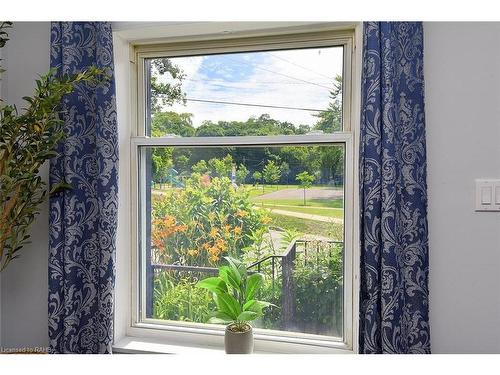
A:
152,47,342,127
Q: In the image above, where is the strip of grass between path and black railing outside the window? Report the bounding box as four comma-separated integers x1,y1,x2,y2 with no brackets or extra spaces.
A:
268,212,343,240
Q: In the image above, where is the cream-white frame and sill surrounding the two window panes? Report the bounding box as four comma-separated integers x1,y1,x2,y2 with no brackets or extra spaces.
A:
127,27,359,353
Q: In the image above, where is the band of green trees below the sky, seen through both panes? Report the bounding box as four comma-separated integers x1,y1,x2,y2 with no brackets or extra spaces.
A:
146,59,344,187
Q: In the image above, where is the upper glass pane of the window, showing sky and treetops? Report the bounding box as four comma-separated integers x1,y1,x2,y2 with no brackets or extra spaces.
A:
145,46,343,137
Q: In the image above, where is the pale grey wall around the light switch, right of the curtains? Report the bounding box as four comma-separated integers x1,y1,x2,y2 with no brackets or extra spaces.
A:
424,22,500,353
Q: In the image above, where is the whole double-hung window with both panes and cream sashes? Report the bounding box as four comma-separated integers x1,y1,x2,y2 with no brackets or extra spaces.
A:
132,31,354,347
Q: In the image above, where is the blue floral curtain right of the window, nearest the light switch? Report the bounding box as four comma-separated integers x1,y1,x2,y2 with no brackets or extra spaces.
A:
359,22,430,353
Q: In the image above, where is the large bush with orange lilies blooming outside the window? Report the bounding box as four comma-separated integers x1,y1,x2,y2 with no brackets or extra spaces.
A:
151,173,266,266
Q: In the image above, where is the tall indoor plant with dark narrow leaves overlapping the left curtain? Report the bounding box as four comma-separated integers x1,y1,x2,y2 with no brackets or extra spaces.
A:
0,22,105,271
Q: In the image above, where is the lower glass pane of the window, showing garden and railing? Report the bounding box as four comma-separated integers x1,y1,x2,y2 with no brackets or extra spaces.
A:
141,144,345,338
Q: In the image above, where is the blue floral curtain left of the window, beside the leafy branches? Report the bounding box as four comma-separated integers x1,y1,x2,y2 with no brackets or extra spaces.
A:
48,22,118,353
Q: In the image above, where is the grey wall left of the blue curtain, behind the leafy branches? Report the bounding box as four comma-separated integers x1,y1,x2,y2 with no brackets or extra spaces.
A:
0,22,50,347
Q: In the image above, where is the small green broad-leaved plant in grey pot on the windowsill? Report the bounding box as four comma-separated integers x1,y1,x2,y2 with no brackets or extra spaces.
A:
196,257,274,354
